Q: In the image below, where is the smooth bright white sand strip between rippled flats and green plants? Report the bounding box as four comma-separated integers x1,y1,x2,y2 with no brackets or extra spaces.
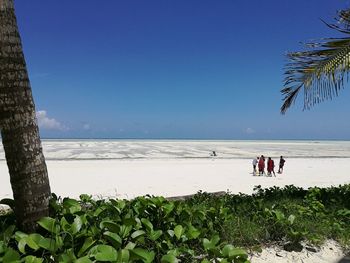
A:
0,158,350,199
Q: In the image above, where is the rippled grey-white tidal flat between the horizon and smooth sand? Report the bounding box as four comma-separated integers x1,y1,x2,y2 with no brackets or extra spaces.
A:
0,140,350,161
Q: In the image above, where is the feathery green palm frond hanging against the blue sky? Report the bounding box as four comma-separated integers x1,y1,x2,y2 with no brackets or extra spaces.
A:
281,10,350,114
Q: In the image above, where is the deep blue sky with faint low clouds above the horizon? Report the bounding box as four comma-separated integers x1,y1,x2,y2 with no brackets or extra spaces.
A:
15,0,350,139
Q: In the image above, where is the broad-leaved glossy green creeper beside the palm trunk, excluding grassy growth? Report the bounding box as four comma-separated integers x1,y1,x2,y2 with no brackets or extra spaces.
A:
0,195,249,262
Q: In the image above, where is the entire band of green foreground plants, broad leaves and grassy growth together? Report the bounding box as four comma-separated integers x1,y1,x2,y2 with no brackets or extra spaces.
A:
0,185,350,263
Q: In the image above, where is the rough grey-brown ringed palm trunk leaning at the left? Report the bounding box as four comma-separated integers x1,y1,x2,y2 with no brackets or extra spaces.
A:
0,0,51,232
